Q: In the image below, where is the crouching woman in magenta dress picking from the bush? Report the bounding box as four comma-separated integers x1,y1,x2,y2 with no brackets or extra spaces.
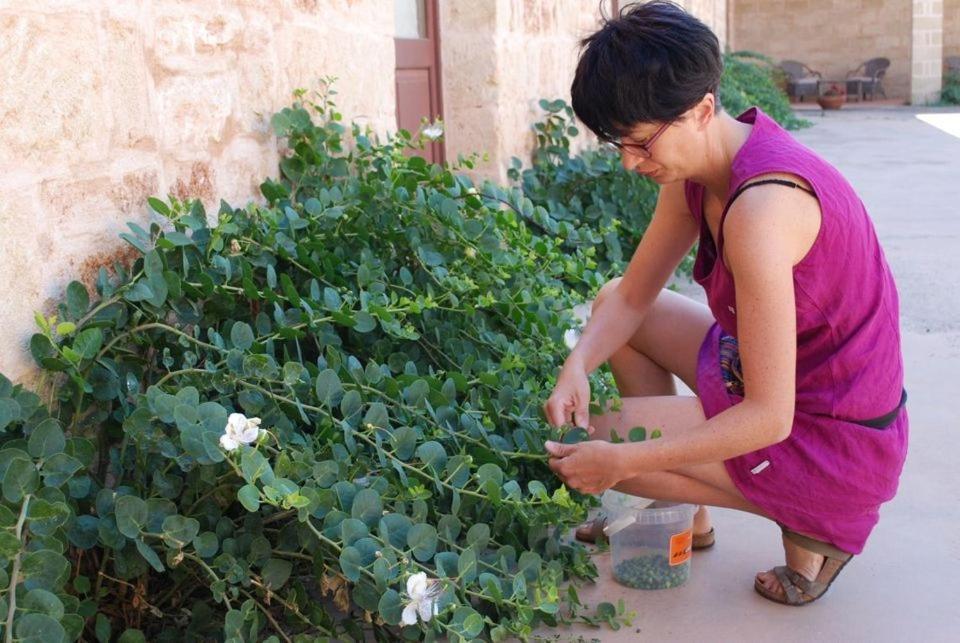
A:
544,2,908,605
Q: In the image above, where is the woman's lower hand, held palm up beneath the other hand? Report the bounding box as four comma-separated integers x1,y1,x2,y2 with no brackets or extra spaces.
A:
544,440,628,493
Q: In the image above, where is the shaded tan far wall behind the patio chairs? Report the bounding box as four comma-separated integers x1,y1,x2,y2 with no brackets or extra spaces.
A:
730,0,913,99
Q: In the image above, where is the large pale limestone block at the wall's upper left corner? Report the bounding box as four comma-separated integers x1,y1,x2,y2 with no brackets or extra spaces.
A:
0,13,107,164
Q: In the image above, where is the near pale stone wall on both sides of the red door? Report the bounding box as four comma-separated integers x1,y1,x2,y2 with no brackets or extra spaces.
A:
0,0,726,378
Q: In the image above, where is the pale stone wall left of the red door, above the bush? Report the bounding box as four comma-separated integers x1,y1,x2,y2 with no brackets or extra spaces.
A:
0,0,396,377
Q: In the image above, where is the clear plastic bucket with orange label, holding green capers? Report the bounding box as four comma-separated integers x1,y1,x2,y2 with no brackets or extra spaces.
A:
602,490,697,589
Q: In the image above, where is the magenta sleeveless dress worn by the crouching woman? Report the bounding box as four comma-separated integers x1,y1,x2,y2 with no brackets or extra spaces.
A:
685,108,908,554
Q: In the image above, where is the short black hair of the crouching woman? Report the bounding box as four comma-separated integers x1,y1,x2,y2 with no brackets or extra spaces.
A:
570,0,723,140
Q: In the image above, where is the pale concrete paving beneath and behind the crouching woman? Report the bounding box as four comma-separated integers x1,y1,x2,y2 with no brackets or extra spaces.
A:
544,107,960,643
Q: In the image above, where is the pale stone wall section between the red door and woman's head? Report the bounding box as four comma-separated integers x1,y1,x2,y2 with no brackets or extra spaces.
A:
440,0,610,182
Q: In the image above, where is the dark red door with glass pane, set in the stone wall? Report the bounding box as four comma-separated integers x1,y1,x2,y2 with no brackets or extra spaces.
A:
394,0,444,163
